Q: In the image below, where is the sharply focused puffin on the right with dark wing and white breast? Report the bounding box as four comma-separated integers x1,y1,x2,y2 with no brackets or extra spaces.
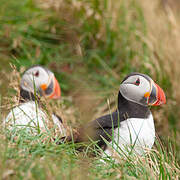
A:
62,72,166,157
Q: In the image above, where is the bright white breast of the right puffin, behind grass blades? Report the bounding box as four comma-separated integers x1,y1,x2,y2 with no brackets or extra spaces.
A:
105,114,155,156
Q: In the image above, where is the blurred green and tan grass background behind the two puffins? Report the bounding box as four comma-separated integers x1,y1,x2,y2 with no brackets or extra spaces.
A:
0,0,180,179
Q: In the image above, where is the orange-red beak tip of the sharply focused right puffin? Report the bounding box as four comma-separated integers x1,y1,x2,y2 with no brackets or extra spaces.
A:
152,83,166,106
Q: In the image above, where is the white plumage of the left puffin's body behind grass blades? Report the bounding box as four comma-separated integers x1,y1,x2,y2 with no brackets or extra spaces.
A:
5,101,65,135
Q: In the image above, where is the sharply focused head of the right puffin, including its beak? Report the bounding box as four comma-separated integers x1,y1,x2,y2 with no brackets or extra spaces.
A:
119,73,166,106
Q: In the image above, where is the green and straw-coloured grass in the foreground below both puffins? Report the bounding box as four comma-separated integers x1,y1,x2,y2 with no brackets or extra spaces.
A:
0,127,180,179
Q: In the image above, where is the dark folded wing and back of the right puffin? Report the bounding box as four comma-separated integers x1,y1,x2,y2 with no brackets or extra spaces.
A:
60,111,125,148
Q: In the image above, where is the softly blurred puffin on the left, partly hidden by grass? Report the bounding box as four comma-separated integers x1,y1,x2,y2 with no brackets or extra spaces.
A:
5,65,65,135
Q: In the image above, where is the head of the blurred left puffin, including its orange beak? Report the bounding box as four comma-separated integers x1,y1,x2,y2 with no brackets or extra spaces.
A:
20,65,61,99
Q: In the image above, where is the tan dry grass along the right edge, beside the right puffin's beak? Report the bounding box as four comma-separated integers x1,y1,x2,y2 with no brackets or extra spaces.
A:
139,0,180,134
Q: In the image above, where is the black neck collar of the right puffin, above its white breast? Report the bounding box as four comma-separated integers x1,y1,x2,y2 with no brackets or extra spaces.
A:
118,92,150,119
